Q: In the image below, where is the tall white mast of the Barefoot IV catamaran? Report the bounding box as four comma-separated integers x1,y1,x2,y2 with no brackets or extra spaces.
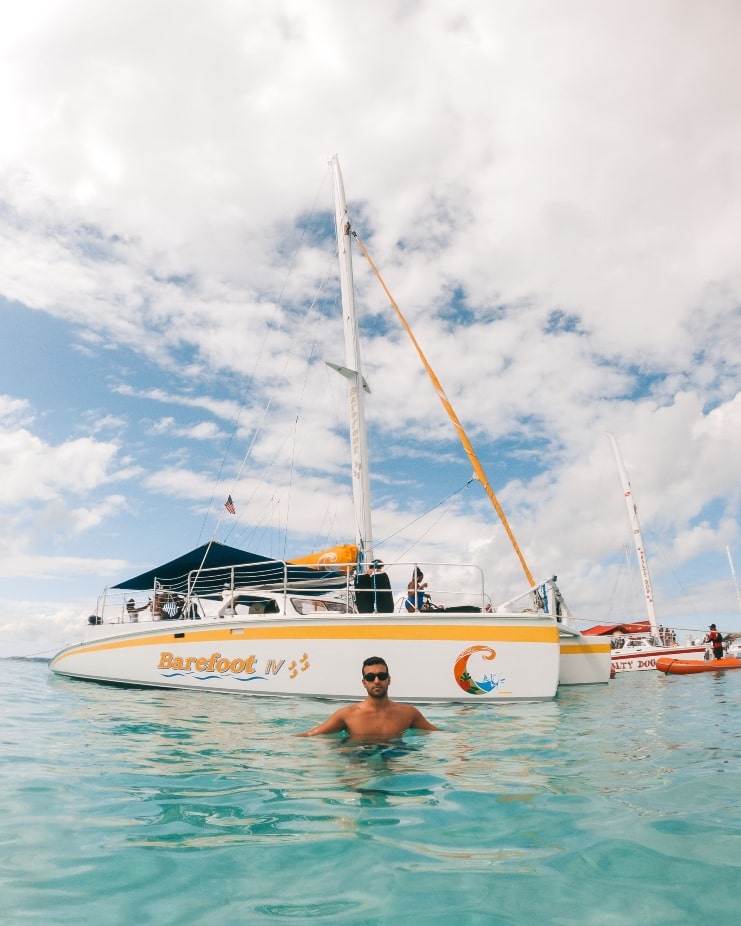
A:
329,155,373,566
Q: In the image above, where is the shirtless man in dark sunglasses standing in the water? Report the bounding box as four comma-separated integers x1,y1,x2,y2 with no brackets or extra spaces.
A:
298,656,440,738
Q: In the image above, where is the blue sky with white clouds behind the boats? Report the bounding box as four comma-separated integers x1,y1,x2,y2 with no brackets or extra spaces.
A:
0,0,741,650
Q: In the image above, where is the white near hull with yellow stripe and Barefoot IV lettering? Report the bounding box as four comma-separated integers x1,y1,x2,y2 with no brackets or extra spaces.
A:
51,614,559,702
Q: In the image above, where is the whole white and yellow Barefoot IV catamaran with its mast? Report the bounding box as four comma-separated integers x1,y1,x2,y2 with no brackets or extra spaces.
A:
51,157,609,704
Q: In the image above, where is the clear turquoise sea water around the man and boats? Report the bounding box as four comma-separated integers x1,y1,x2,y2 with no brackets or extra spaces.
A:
0,660,741,926
